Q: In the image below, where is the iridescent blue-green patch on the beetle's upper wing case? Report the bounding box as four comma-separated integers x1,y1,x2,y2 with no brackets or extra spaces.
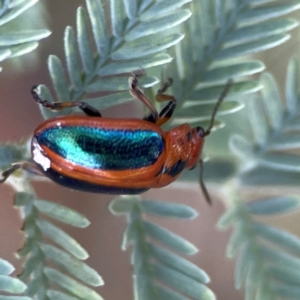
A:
36,126,165,170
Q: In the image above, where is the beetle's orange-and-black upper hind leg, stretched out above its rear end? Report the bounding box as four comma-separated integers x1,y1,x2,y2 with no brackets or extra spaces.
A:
31,86,101,117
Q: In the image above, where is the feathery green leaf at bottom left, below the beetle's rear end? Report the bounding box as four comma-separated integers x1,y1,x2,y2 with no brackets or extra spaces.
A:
15,192,103,300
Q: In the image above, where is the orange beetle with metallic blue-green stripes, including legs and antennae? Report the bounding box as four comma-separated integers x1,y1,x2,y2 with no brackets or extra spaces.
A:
0,76,230,202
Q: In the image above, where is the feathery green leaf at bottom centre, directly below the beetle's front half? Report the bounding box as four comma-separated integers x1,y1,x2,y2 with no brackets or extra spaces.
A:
110,197,216,300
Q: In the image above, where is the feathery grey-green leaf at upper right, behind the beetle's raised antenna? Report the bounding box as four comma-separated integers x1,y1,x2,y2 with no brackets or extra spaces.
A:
168,0,300,126
